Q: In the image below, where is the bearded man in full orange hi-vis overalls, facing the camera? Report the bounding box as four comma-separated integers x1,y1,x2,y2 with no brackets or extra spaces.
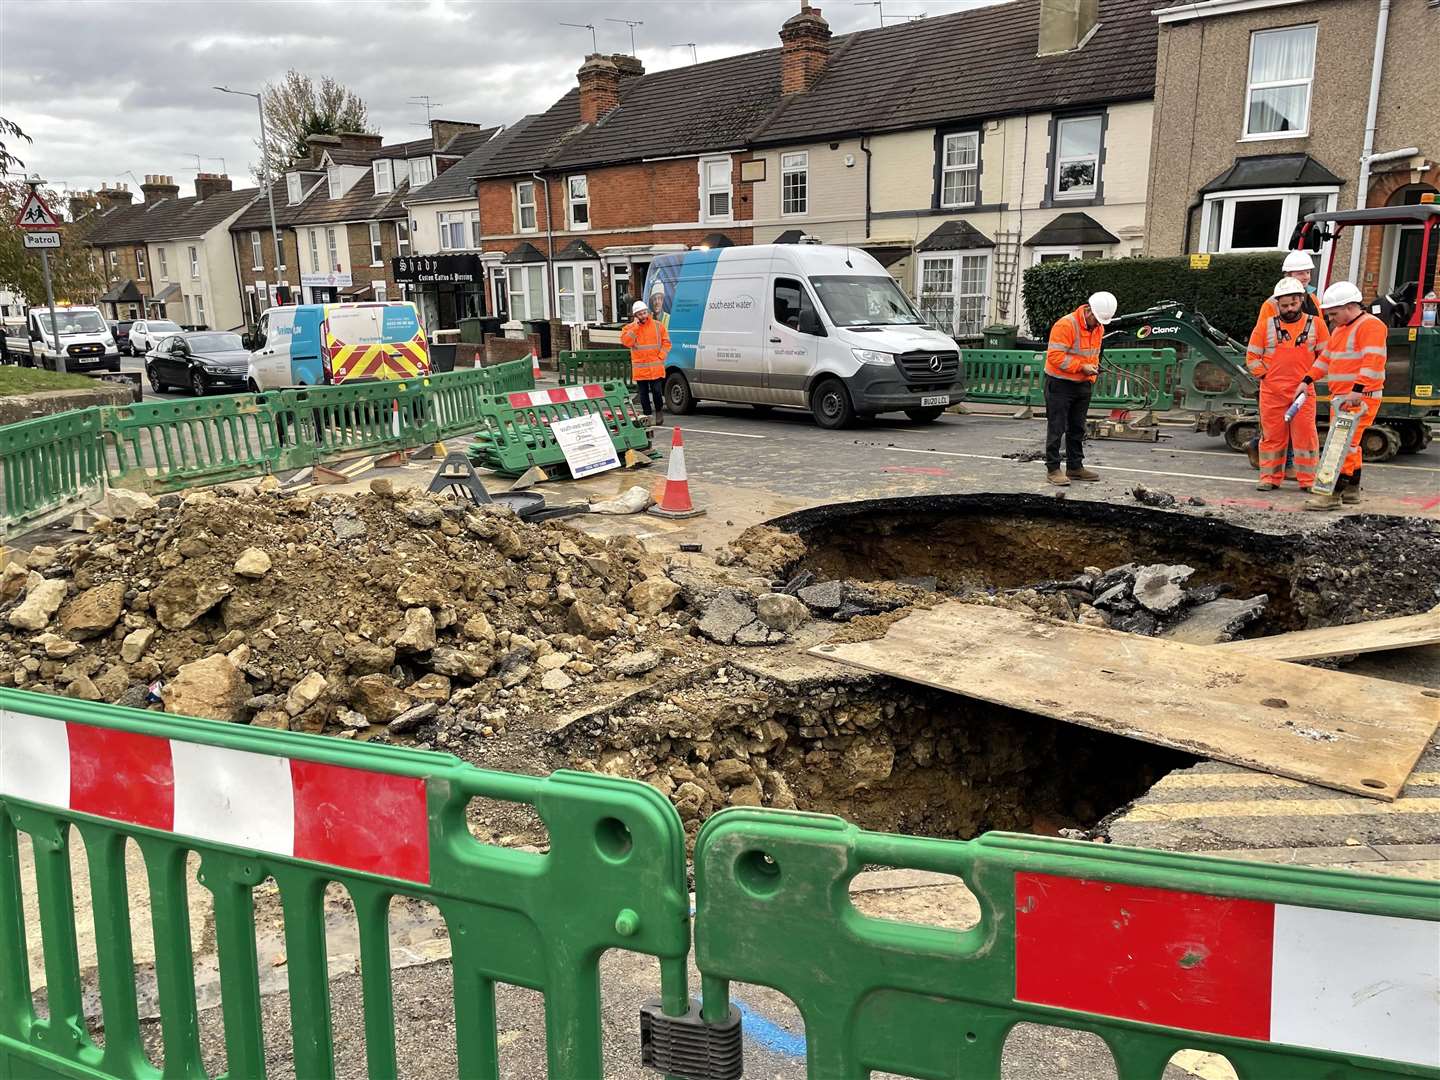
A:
1246,278,1329,491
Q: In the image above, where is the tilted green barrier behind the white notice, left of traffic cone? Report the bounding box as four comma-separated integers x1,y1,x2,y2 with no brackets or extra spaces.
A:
469,383,649,475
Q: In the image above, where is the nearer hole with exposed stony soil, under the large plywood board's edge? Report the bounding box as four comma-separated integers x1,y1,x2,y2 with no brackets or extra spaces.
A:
564,668,1197,841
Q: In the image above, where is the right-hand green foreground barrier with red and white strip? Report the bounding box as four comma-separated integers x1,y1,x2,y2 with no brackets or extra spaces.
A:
694,809,1440,1080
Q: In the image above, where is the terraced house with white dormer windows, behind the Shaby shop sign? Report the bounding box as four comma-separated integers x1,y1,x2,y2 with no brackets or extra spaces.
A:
230,120,494,323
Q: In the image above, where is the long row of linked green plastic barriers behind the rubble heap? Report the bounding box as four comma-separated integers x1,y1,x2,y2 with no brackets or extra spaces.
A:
0,360,534,537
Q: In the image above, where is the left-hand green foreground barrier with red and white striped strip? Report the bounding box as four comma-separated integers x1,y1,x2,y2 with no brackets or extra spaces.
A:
0,690,690,1080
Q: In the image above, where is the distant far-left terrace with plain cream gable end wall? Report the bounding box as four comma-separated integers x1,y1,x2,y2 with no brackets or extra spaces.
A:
85,173,256,330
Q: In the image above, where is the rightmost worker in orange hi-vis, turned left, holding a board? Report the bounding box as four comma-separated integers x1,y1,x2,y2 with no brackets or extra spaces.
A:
1305,281,1387,510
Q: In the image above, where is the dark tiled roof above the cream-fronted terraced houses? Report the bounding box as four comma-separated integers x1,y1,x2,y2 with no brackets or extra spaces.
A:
753,0,1158,144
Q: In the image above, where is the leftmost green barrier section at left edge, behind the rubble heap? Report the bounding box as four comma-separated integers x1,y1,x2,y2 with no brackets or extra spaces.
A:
0,408,105,526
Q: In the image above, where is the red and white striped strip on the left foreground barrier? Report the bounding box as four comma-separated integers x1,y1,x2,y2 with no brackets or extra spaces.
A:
0,710,431,883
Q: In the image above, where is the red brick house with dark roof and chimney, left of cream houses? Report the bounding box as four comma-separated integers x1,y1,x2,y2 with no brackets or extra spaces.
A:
475,49,780,334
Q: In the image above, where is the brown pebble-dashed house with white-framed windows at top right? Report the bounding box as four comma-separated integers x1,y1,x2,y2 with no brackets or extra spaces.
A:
1146,0,1440,295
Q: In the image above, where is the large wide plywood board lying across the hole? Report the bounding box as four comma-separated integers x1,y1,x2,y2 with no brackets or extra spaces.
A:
811,603,1440,799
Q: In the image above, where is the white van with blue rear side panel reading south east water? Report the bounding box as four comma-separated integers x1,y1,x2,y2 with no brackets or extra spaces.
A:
645,243,962,428
